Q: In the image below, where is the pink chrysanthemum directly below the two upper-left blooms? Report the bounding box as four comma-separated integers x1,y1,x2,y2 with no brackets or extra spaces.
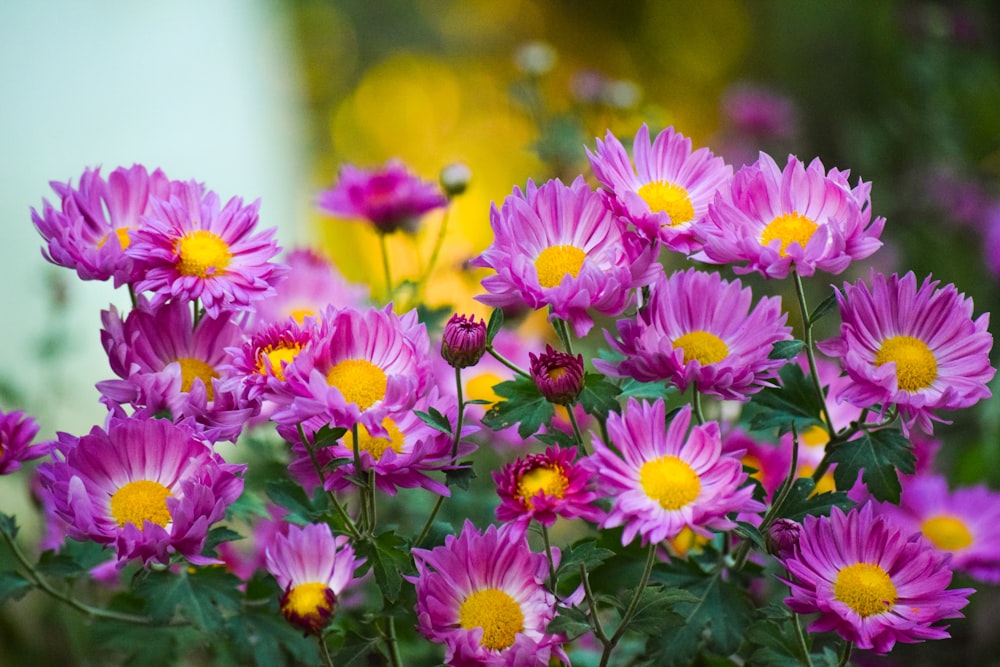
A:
97,301,259,442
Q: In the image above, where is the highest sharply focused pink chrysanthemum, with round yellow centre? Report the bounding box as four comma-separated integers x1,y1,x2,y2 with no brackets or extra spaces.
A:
587,124,733,253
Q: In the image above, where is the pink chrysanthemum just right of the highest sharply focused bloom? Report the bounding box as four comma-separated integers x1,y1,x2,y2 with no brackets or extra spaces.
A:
695,153,885,278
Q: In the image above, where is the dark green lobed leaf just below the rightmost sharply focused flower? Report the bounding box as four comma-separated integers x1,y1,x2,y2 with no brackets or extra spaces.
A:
829,429,916,504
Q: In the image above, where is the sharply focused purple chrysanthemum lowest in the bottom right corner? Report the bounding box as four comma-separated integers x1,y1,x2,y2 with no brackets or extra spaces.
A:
782,504,973,653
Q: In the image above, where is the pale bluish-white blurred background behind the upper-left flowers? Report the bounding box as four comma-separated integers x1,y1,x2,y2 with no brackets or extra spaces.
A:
0,0,312,437
